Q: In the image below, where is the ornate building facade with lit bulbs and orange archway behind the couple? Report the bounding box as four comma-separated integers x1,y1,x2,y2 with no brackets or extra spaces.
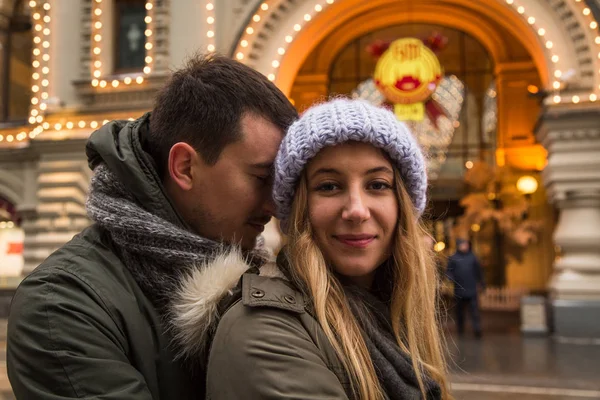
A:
0,0,600,337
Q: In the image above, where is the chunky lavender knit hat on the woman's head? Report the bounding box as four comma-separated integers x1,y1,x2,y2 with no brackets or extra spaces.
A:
273,99,427,230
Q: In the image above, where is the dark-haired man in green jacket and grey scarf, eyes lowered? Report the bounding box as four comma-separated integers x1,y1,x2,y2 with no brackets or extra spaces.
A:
7,56,297,400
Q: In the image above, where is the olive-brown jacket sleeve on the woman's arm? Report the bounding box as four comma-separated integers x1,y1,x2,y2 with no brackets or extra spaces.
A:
207,303,348,400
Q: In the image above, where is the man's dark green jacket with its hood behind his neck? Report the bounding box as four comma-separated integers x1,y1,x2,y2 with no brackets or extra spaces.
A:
7,116,203,400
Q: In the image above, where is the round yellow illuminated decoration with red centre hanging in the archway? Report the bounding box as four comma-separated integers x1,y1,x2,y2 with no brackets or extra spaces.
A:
374,38,442,121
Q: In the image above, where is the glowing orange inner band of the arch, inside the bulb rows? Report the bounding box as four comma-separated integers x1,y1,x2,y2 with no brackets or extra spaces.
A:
275,0,549,95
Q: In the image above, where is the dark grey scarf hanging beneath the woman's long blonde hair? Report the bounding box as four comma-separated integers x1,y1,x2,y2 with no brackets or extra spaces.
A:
345,285,441,400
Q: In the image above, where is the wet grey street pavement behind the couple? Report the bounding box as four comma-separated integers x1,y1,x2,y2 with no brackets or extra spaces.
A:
0,320,600,400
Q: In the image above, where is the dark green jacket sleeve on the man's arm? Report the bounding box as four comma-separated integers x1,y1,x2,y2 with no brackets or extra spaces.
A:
7,268,152,400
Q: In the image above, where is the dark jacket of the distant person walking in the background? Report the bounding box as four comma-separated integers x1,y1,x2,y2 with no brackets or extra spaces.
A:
446,242,485,299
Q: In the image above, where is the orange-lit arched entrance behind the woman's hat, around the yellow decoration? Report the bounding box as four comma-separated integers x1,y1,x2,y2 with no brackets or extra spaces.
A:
289,18,553,289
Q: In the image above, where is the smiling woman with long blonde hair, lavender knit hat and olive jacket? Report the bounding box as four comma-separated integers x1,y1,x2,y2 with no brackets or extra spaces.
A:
170,99,450,399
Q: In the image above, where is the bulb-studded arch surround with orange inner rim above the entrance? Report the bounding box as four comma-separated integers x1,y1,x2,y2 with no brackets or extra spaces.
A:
232,0,600,98
